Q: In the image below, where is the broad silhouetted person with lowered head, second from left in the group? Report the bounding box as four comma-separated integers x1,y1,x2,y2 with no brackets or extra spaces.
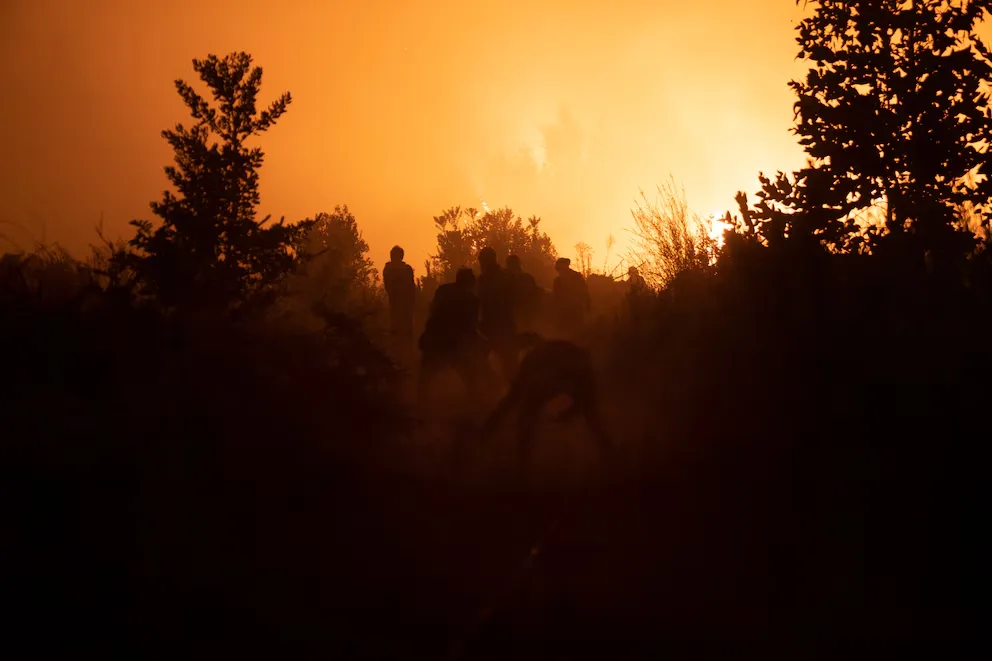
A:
417,268,488,403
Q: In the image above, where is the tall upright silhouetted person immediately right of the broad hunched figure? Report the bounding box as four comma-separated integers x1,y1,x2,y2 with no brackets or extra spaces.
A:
477,247,518,381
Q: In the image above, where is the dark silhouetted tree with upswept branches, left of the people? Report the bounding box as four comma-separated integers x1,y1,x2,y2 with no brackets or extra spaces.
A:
125,53,312,307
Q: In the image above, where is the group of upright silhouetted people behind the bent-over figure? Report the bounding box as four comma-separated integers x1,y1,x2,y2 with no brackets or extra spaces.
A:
383,246,592,398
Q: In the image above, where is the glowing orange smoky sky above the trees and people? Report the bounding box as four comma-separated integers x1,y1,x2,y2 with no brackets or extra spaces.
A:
0,0,802,273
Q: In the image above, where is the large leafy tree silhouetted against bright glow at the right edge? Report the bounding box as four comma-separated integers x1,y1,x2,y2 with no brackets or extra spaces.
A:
752,0,992,251
